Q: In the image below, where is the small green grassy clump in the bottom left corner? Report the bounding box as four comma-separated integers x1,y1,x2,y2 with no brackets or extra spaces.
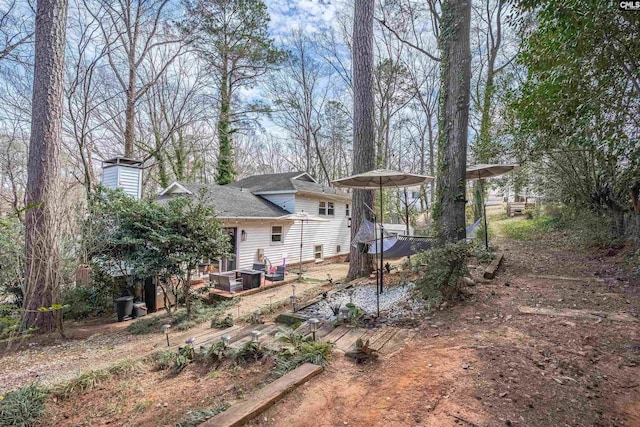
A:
0,384,49,427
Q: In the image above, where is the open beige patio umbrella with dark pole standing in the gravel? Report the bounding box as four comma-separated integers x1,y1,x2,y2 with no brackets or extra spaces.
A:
331,169,433,315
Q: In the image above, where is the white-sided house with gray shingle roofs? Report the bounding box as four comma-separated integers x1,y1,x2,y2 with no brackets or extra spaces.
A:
159,172,351,271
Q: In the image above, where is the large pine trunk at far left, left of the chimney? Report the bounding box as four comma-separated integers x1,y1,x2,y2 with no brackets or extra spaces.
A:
23,0,68,331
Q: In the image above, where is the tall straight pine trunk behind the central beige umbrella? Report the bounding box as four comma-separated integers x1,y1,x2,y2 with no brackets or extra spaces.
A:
348,0,375,278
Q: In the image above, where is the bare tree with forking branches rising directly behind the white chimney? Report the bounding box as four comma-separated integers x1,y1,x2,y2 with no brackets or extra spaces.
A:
84,0,183,157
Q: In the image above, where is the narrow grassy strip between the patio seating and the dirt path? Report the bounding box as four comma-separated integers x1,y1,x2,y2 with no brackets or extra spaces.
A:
127,300,237,335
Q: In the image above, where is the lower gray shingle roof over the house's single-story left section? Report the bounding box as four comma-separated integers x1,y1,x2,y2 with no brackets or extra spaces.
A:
159,182,289,218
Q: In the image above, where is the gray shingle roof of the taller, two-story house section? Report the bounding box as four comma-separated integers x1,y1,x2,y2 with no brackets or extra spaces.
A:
229,171,343,199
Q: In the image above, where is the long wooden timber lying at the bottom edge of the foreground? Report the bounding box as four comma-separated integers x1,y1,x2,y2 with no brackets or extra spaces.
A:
200,363,322,427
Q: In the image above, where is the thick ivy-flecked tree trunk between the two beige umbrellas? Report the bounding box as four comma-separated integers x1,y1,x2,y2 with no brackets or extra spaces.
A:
434,0,471,243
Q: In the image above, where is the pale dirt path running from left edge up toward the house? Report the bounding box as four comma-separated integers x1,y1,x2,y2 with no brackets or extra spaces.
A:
0,263,348,395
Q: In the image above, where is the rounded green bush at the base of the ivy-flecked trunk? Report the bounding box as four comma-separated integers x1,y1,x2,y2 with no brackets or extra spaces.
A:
411,241,473,306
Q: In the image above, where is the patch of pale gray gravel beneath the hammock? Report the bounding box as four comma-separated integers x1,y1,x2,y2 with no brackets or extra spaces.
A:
298,283,414,320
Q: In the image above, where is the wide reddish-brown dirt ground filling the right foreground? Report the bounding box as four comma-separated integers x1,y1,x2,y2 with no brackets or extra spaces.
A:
252,229,640,427
